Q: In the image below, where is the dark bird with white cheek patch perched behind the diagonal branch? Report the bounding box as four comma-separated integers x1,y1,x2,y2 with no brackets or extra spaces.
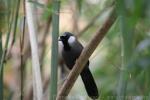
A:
58,32,99,99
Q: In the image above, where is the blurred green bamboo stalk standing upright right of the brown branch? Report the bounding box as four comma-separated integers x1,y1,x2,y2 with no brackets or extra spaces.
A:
117,0,133,100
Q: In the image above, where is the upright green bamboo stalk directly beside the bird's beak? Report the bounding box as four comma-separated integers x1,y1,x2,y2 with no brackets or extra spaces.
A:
50,0,60,100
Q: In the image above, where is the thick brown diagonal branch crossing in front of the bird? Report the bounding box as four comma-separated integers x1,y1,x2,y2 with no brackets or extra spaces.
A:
56,7,117,100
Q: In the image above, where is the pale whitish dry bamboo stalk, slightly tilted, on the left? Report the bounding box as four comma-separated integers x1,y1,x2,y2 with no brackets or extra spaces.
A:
26,0,43,100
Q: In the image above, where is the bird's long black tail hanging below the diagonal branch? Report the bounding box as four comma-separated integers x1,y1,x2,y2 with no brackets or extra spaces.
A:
81,67,99,99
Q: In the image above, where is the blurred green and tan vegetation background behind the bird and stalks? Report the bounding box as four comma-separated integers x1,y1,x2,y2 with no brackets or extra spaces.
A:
0,0,150,100
